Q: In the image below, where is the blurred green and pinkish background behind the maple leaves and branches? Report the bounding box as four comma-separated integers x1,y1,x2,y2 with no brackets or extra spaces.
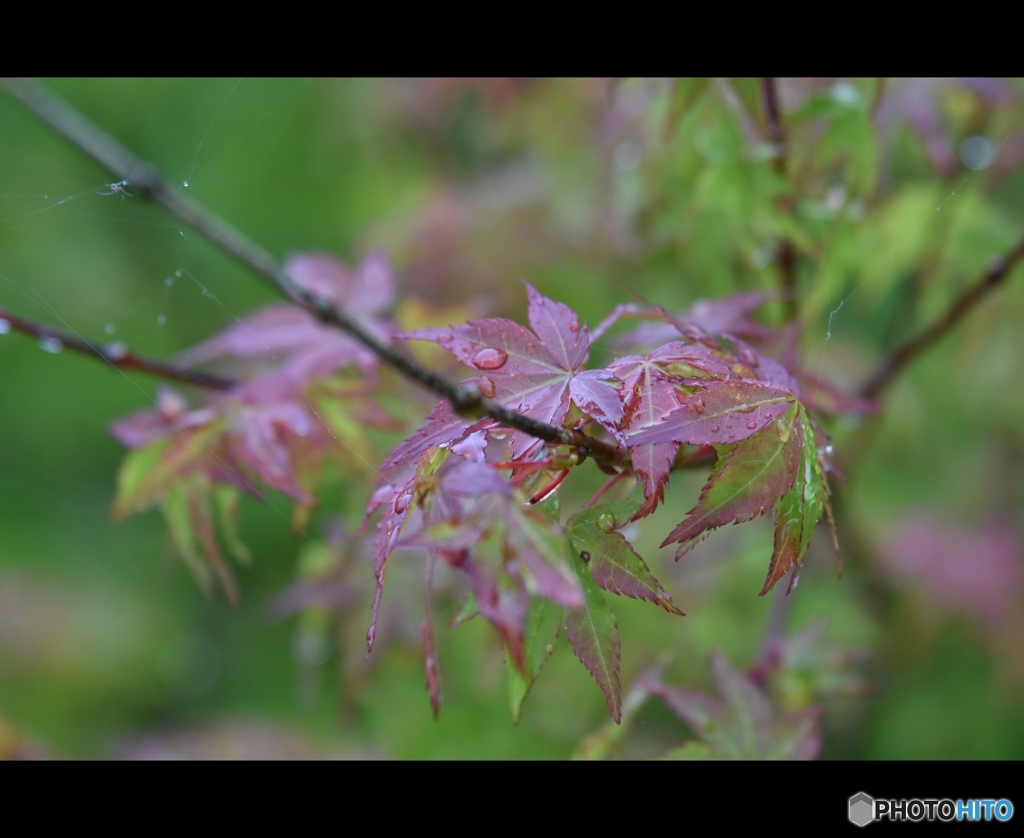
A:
0,79,1024,758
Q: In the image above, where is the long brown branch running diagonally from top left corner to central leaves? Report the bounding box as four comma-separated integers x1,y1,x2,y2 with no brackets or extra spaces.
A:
3,79,626,463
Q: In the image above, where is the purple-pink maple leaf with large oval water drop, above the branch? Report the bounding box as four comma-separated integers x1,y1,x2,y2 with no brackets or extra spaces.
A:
397,283,623,459
